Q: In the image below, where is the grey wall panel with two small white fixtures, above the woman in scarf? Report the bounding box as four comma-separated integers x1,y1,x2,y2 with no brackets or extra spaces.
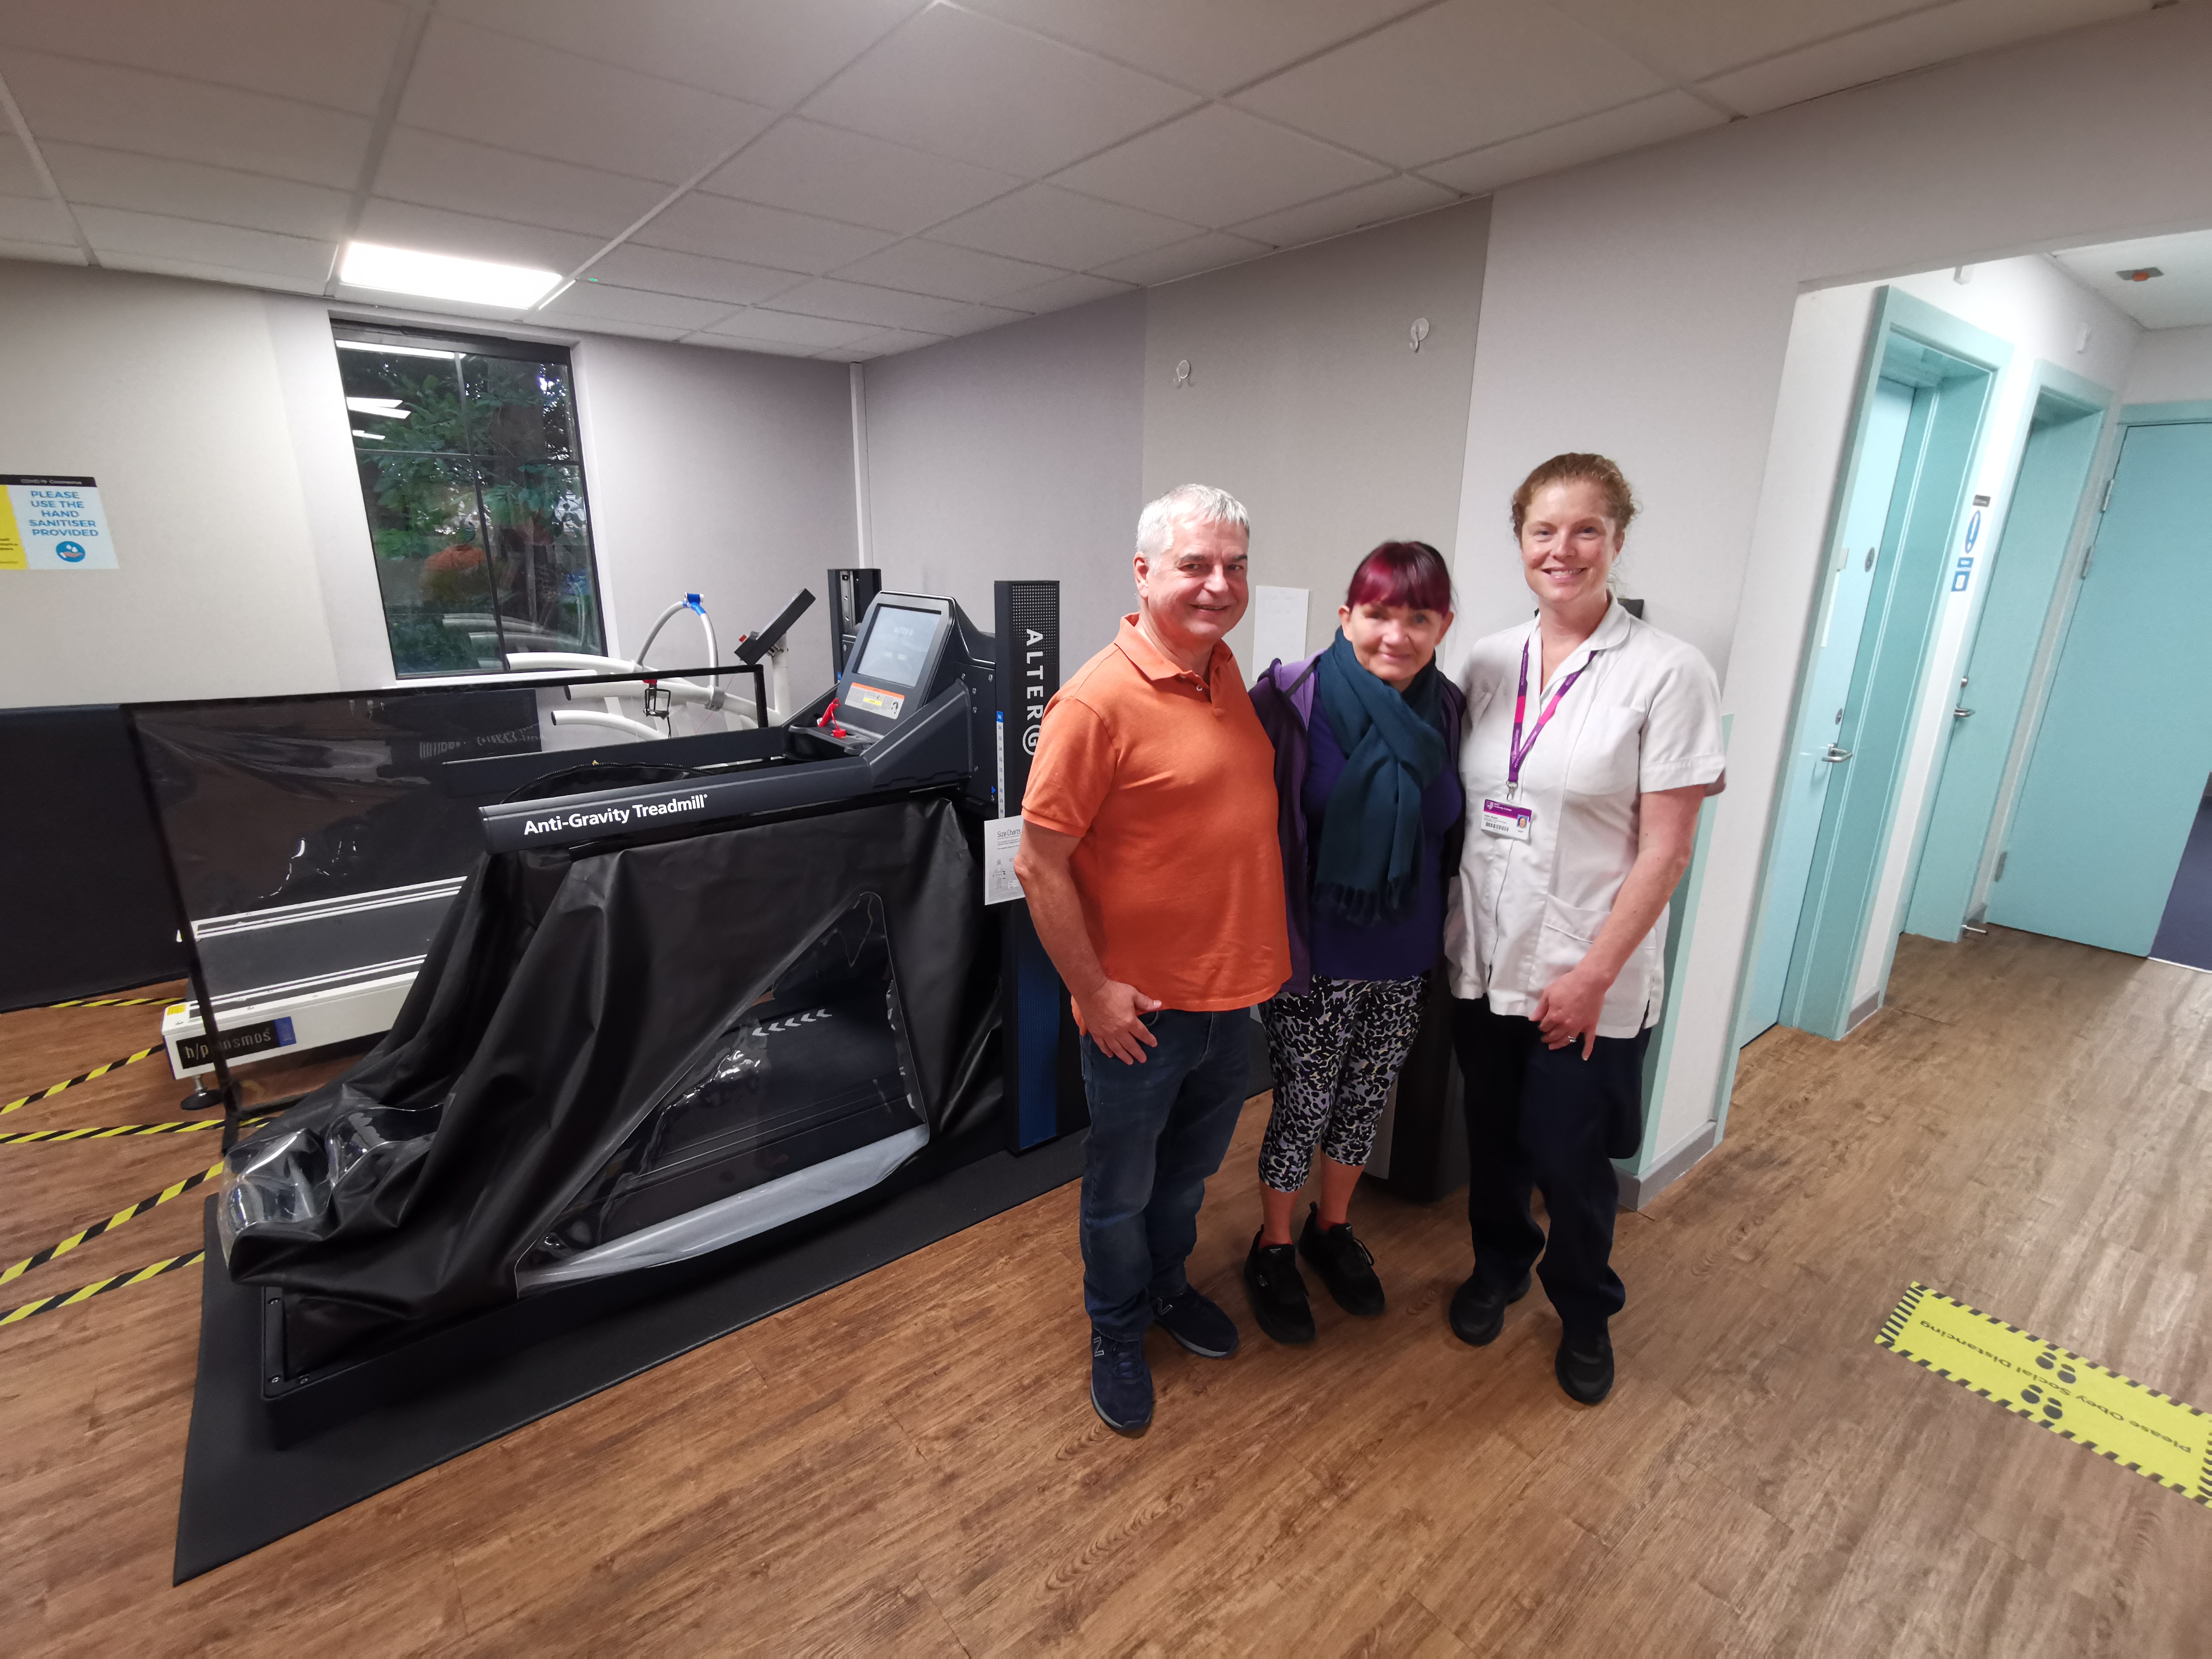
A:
1144,201,1489,677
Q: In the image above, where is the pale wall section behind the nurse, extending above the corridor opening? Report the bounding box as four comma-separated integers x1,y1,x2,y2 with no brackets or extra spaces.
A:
1458,6,2212,1157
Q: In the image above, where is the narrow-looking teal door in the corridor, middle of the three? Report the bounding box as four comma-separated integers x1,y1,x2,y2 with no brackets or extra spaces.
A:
1904,400,2104,942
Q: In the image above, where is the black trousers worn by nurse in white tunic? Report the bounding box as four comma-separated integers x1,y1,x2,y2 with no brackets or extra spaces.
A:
1451,998,1650,1336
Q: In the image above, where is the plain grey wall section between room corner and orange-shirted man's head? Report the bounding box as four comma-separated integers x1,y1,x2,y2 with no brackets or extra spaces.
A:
858,294,1144,668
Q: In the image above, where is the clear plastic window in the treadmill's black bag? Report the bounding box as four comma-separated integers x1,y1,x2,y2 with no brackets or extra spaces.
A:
515,893,929,1292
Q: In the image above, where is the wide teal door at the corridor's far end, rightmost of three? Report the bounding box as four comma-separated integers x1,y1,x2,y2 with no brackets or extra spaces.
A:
1989,423,2212,956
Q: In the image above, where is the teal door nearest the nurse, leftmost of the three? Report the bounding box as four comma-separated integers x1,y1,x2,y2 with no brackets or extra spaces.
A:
1736,378,1913,1044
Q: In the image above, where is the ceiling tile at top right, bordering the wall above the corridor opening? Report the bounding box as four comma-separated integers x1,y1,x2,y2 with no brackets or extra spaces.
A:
1703,0,2143,115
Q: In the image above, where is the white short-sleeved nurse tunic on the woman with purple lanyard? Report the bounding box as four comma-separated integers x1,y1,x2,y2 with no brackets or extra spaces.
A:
1444,604,1723,1037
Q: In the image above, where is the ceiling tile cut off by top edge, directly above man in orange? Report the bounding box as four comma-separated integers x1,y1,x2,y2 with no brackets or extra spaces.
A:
969,0,1422,93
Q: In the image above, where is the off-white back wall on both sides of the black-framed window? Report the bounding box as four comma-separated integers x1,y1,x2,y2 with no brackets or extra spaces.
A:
0,261,854,708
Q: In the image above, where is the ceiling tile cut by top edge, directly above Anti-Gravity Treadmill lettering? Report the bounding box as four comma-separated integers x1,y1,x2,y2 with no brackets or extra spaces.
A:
438,0,922,108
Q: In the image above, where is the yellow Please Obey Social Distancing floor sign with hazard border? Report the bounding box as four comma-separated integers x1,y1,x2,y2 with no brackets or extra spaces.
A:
1874,1283,2212,1509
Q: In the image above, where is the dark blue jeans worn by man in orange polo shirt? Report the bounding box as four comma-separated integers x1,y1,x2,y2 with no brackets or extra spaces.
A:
1082,1009,1252,1338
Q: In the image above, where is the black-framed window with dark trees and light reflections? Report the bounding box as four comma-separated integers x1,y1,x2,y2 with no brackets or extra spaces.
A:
334,323,604,675
